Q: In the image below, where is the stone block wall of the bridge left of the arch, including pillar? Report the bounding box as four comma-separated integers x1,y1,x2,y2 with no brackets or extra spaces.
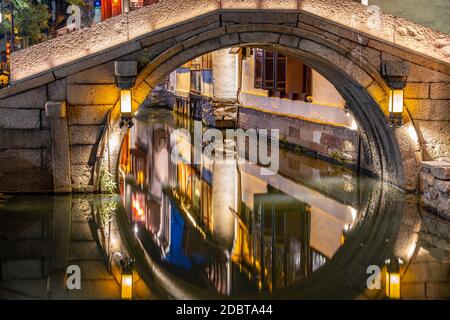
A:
0,62,119,193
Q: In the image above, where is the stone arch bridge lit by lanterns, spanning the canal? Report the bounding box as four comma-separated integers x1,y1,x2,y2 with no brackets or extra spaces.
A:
0,0,450,192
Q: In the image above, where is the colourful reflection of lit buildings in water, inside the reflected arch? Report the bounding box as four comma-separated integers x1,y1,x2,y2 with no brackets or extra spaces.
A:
120,112,355,294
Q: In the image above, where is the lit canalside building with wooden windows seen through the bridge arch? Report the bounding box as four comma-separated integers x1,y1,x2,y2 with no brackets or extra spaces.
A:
166,48,360,165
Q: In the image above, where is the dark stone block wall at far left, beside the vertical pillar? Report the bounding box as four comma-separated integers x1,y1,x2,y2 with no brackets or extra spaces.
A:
0,86,54,192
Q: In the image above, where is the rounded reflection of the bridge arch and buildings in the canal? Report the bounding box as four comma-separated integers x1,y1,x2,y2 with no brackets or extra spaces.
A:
119,110,417,299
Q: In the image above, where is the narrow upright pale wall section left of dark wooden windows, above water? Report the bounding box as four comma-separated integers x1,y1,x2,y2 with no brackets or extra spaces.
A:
213,49,238,99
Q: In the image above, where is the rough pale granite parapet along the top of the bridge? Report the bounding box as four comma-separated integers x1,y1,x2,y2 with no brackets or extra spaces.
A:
7,0,450,83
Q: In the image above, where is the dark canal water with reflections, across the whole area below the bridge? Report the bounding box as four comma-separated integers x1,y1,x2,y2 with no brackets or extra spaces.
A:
0,109,450,299
